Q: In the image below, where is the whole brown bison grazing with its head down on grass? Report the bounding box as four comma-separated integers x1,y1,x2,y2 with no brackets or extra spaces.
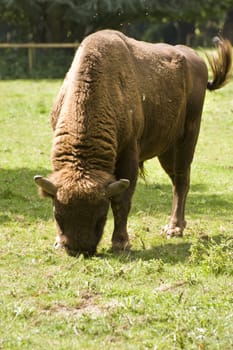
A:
35,30,232,256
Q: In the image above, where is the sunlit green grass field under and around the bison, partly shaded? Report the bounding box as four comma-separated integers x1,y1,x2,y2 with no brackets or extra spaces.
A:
0,80,233,350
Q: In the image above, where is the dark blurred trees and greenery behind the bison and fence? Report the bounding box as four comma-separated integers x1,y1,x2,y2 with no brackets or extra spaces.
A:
0,0,233,79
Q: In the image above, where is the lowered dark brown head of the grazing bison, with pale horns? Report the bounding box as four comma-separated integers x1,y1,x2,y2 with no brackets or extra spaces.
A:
34,175,129,256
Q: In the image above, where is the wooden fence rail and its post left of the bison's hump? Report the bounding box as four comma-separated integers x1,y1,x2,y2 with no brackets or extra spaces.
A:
0,43,79,73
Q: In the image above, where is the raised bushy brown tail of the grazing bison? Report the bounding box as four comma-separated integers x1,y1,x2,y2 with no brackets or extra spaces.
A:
206,37,232,91
